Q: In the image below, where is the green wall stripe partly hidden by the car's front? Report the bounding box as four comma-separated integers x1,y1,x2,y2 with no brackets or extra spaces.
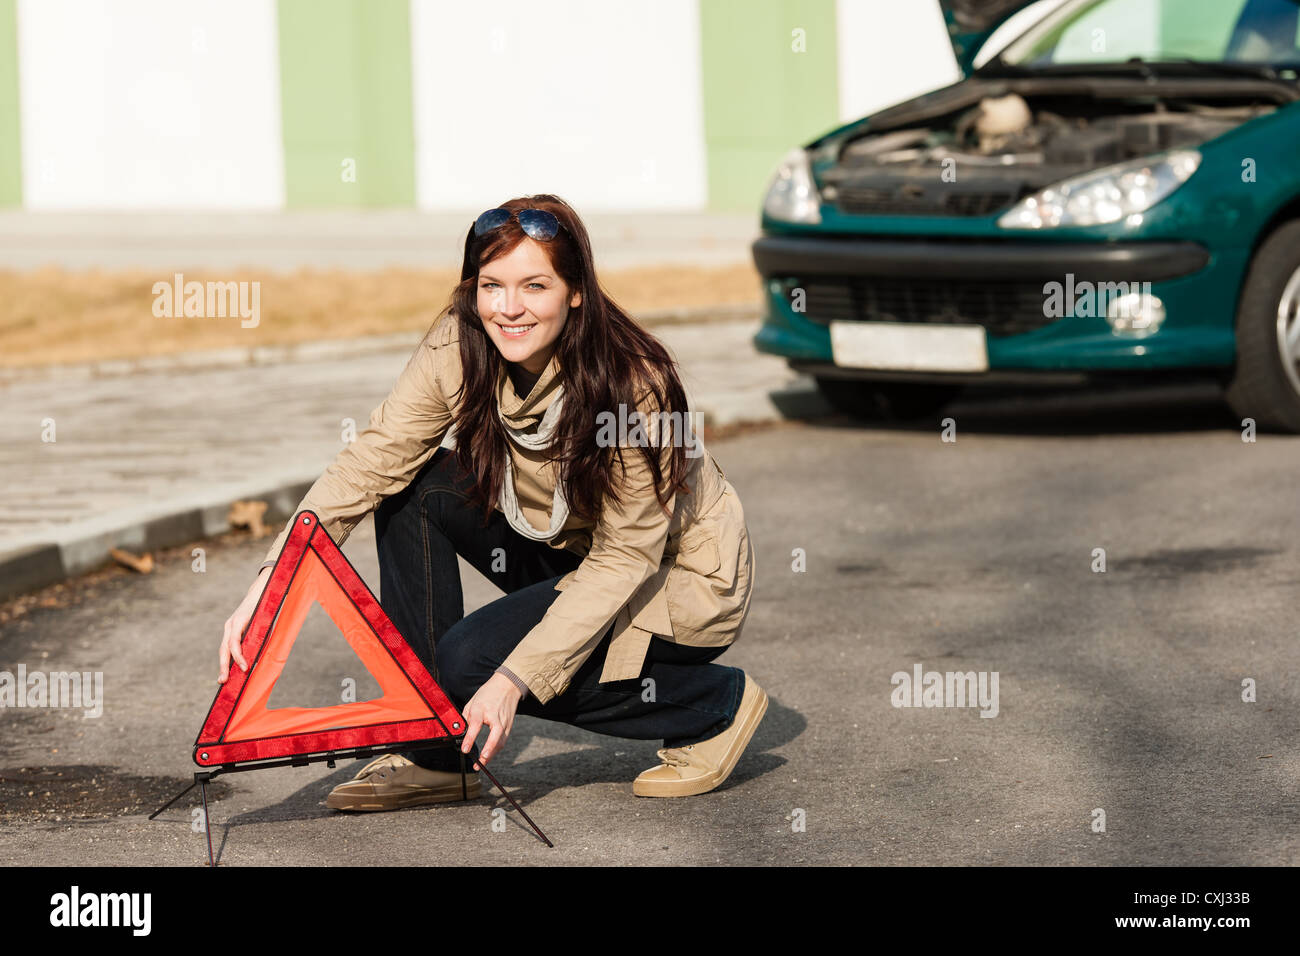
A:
699,0,840,212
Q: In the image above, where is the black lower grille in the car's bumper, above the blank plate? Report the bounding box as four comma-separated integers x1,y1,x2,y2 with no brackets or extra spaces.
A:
785,276,1056,337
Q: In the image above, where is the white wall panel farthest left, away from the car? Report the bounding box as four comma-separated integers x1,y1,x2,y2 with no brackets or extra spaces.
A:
18,0,285,209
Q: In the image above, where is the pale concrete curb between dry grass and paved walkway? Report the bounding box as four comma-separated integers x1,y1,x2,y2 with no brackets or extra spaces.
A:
0,304,762,385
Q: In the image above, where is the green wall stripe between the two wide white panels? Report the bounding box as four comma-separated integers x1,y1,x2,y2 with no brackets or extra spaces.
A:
276,0,415,208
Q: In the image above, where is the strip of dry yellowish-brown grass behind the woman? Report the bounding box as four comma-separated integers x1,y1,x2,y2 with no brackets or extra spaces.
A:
0,265,759,367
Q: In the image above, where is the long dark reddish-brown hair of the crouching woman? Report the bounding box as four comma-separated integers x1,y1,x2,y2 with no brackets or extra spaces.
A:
439,193,689,524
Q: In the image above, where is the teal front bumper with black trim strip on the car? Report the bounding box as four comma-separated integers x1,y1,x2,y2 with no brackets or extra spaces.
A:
753,235,1248,380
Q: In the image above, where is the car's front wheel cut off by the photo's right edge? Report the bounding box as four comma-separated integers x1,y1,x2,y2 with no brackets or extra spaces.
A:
1226,220,1300,432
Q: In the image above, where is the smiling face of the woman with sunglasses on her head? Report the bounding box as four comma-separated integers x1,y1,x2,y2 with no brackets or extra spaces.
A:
478,238,582,375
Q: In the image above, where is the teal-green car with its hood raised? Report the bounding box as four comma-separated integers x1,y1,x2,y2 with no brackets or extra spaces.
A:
753,0,1300,432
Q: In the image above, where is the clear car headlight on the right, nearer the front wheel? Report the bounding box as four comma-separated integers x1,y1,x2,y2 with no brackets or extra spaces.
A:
997,150,1201,229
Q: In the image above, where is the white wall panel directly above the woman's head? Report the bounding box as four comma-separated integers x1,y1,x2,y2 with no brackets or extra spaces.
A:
411,0,707,212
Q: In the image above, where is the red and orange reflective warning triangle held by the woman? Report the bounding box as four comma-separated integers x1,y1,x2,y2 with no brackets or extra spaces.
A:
194,511,465,766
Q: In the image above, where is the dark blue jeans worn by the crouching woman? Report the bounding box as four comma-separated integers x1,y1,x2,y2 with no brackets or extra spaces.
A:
374,449,745,771
